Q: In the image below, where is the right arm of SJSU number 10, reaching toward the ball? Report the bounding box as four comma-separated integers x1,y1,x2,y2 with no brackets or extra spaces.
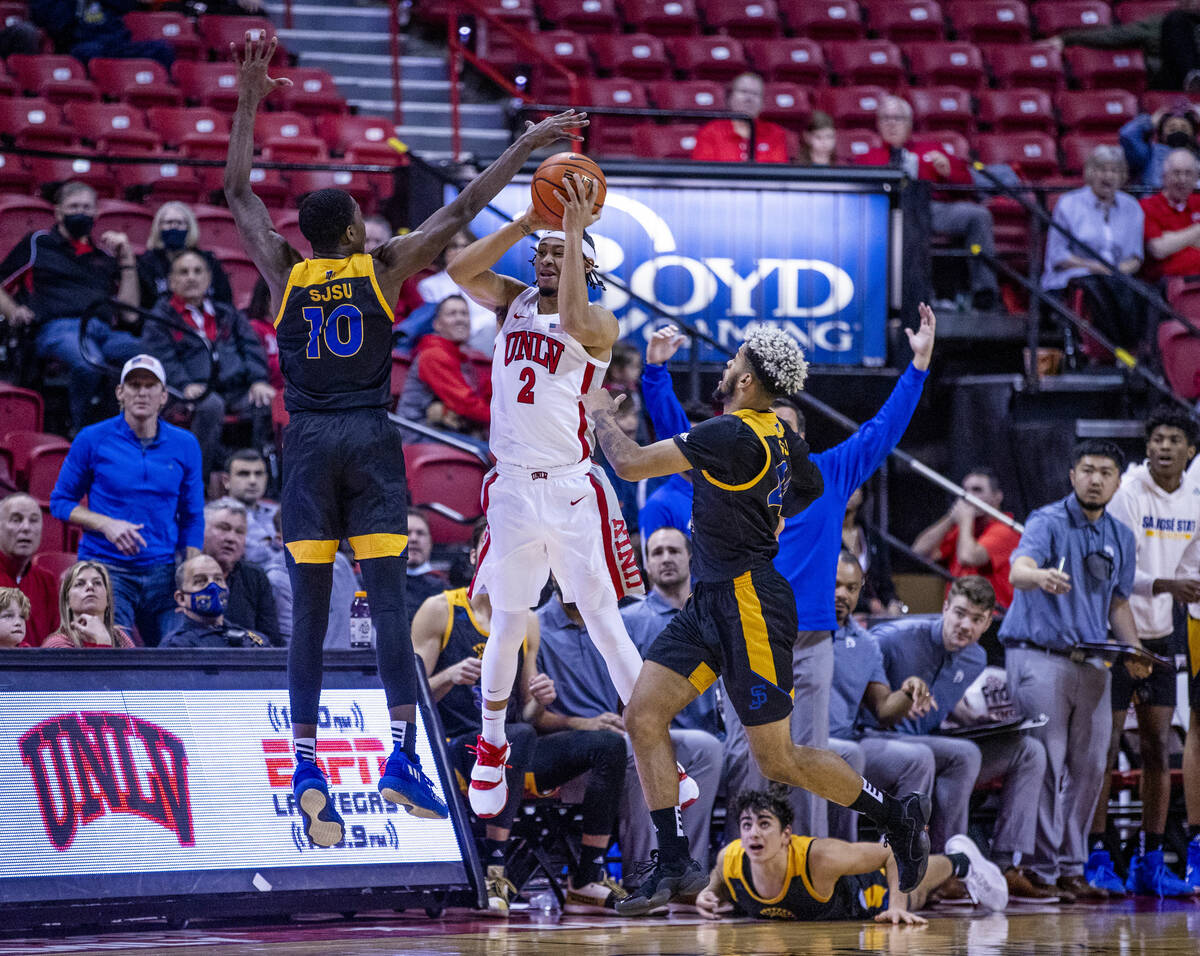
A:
372,109,588,289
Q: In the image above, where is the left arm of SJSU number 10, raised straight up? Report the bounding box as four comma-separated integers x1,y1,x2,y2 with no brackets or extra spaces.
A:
224,34,300,303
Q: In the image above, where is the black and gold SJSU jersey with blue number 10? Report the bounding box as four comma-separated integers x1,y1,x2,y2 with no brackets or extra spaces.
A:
275,252,392,411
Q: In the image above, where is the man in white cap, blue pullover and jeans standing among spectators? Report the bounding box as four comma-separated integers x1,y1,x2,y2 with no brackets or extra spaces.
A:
50,355,204,647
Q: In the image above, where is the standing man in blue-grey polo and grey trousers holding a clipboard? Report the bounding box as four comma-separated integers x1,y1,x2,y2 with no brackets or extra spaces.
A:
1000,439,1151,902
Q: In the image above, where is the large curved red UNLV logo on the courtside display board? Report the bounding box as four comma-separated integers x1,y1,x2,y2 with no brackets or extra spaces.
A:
20,711,196,850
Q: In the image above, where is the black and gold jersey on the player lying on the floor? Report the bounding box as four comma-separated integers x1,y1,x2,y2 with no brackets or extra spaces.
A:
721,835,888,922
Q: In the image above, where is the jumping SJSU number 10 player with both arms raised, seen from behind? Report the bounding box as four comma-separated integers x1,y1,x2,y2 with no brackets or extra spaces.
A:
224,34,586,847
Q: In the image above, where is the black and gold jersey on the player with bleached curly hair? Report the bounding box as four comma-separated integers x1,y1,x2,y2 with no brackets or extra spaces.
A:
674,409,824,582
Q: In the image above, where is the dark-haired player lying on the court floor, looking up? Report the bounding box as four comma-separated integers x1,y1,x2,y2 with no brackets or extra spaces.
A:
696,788,1008,924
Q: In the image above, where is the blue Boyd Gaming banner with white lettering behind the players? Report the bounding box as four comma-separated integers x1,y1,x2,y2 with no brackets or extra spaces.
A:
446,178,888,365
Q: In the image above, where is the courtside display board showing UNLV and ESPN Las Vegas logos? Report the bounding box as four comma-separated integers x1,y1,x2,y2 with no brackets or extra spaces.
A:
0,690,462,900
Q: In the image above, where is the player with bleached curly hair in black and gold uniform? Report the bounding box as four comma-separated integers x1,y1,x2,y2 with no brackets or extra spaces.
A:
583,303,935,915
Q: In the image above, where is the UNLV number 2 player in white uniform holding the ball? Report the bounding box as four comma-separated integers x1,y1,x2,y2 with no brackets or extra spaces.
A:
449,179,698,817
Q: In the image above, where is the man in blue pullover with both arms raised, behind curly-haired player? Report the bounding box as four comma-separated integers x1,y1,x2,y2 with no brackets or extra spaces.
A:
642,313,937,836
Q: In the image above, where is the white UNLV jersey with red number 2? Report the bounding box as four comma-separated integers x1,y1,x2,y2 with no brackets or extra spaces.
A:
488,288,608,469
